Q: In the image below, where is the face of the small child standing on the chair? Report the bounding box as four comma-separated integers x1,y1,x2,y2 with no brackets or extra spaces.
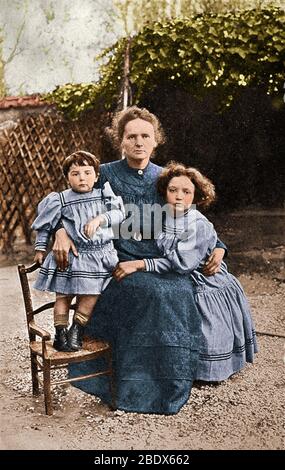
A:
67,163,98,193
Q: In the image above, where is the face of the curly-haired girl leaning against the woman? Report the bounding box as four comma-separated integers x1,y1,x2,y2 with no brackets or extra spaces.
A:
166,176,195,214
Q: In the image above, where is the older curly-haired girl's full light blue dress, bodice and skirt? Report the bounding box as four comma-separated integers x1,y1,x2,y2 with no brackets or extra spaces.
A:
146,208,257,381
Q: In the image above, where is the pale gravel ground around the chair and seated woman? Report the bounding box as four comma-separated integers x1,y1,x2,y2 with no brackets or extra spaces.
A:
0,213,285,450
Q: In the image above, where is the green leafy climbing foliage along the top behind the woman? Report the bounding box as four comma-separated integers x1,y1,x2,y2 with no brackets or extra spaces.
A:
45,7,285,117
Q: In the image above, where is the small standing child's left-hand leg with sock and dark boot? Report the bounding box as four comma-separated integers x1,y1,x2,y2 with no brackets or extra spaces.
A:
53,293,74,351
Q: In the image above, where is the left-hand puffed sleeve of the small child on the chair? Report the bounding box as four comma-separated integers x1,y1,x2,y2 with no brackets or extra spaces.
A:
32,193,62,251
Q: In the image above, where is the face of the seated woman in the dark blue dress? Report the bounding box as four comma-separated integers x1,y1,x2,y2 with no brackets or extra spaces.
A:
121,118,157,168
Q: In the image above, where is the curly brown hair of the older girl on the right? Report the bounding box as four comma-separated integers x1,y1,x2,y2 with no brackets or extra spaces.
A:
157,161,216,209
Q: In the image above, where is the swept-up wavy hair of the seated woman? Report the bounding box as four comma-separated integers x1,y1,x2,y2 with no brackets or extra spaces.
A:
107,106,165,149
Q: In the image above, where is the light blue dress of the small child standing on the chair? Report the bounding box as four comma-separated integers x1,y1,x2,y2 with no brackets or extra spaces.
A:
32,183,124,295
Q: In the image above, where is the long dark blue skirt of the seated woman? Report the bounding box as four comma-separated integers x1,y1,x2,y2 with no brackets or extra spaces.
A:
70,272,201,414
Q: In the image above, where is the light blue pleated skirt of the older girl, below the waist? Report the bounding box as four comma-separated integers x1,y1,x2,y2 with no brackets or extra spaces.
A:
194,273,257,381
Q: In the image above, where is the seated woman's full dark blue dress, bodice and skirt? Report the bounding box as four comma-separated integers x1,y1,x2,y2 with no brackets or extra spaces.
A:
70,160,224,414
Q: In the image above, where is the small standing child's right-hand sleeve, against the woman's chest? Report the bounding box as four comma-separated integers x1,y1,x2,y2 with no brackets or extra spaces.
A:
102,182,125,227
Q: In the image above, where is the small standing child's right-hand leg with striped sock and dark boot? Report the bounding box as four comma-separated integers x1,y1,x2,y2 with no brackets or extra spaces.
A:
68,295,99,351
